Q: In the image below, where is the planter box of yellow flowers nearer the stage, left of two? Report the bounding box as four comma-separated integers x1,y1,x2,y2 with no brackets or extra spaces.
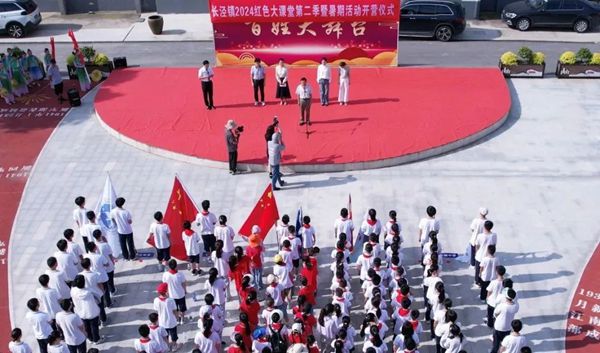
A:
498,47,546,77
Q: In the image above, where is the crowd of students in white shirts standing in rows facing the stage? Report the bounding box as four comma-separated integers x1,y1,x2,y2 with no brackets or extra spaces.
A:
9,197,532,353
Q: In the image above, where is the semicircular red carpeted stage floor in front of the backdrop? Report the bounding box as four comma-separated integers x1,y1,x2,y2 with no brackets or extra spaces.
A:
95,68,510,171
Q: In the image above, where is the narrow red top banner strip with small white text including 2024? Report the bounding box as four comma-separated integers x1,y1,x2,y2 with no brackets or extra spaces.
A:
209,0,400,23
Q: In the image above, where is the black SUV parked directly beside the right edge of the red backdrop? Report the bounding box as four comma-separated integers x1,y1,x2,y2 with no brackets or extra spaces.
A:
400,0,465,42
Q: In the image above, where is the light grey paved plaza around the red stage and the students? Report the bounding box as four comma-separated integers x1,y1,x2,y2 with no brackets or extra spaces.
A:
10,75,600,353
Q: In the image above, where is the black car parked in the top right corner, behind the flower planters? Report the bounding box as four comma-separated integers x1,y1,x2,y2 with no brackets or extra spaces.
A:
502,0,600,33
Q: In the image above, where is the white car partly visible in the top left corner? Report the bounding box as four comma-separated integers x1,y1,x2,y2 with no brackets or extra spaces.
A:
0,0,42,38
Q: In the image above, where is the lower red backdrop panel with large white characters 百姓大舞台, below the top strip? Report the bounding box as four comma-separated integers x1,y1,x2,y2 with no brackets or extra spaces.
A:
213,21,398,66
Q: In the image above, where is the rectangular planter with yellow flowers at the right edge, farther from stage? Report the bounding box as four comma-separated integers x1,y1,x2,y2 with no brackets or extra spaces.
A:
556,48,600,78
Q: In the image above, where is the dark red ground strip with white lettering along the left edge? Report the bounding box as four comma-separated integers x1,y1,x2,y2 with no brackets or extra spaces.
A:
0,81,90,346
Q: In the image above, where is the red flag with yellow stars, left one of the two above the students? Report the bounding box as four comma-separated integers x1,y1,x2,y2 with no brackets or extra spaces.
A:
148,176,198,261
